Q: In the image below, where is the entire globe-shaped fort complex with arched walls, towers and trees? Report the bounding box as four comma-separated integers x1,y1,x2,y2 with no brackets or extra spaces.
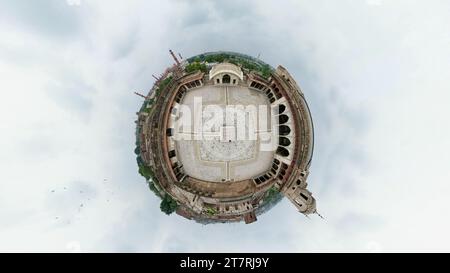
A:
135,51,316,223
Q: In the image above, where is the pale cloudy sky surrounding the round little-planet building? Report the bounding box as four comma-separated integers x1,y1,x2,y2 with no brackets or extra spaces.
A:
0,0,450,252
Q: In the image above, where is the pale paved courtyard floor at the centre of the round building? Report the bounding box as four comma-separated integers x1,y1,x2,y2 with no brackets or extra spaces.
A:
176,85,274,182
